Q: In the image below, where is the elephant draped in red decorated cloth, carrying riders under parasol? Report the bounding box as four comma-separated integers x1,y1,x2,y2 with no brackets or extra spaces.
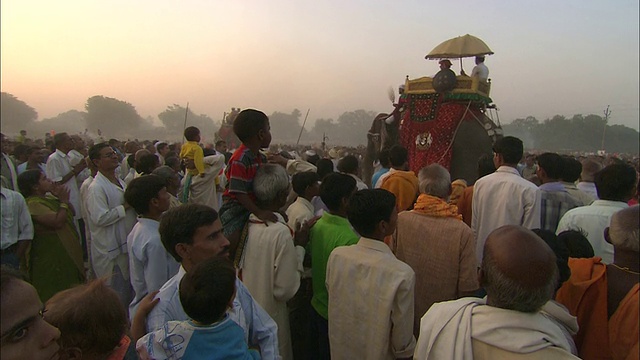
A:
362,76,502,184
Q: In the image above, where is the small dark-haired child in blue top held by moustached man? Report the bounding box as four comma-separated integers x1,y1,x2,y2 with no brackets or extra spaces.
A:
137,256,260,360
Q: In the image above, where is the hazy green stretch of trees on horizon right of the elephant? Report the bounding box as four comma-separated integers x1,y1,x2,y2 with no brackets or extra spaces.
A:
503,114,640,154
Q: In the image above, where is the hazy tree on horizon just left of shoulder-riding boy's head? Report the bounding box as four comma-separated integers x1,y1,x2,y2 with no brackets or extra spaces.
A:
158,104,219,142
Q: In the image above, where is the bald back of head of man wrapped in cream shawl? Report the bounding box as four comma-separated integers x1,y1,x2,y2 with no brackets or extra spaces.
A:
480,225,558,313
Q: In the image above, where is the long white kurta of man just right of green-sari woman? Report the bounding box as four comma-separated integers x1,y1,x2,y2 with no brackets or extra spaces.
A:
87,172,136,279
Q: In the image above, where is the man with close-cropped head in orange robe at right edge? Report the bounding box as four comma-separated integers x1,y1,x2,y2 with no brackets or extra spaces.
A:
557,205,640,359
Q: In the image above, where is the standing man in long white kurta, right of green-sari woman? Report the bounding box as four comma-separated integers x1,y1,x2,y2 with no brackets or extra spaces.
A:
87,144,136,306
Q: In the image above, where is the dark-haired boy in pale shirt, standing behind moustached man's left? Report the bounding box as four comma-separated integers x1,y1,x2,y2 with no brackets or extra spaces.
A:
124,174,180,318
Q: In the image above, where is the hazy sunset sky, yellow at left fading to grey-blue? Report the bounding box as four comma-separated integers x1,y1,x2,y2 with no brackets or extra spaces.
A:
0,0,640,129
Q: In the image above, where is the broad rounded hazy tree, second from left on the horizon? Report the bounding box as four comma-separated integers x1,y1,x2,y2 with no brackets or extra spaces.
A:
85,95,142,138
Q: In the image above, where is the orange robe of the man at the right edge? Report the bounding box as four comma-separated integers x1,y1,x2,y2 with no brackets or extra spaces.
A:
556,257,639,360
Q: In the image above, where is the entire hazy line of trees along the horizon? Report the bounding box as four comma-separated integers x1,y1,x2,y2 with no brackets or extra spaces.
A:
0,92,640,154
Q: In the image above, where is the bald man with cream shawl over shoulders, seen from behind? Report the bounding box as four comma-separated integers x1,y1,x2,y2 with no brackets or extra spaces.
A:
414,225,577,359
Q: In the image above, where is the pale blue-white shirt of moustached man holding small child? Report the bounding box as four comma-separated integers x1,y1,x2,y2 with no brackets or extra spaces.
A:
147,266,280,359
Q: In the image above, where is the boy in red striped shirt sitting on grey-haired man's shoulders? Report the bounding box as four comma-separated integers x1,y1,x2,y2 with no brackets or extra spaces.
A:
220,109,278,265
